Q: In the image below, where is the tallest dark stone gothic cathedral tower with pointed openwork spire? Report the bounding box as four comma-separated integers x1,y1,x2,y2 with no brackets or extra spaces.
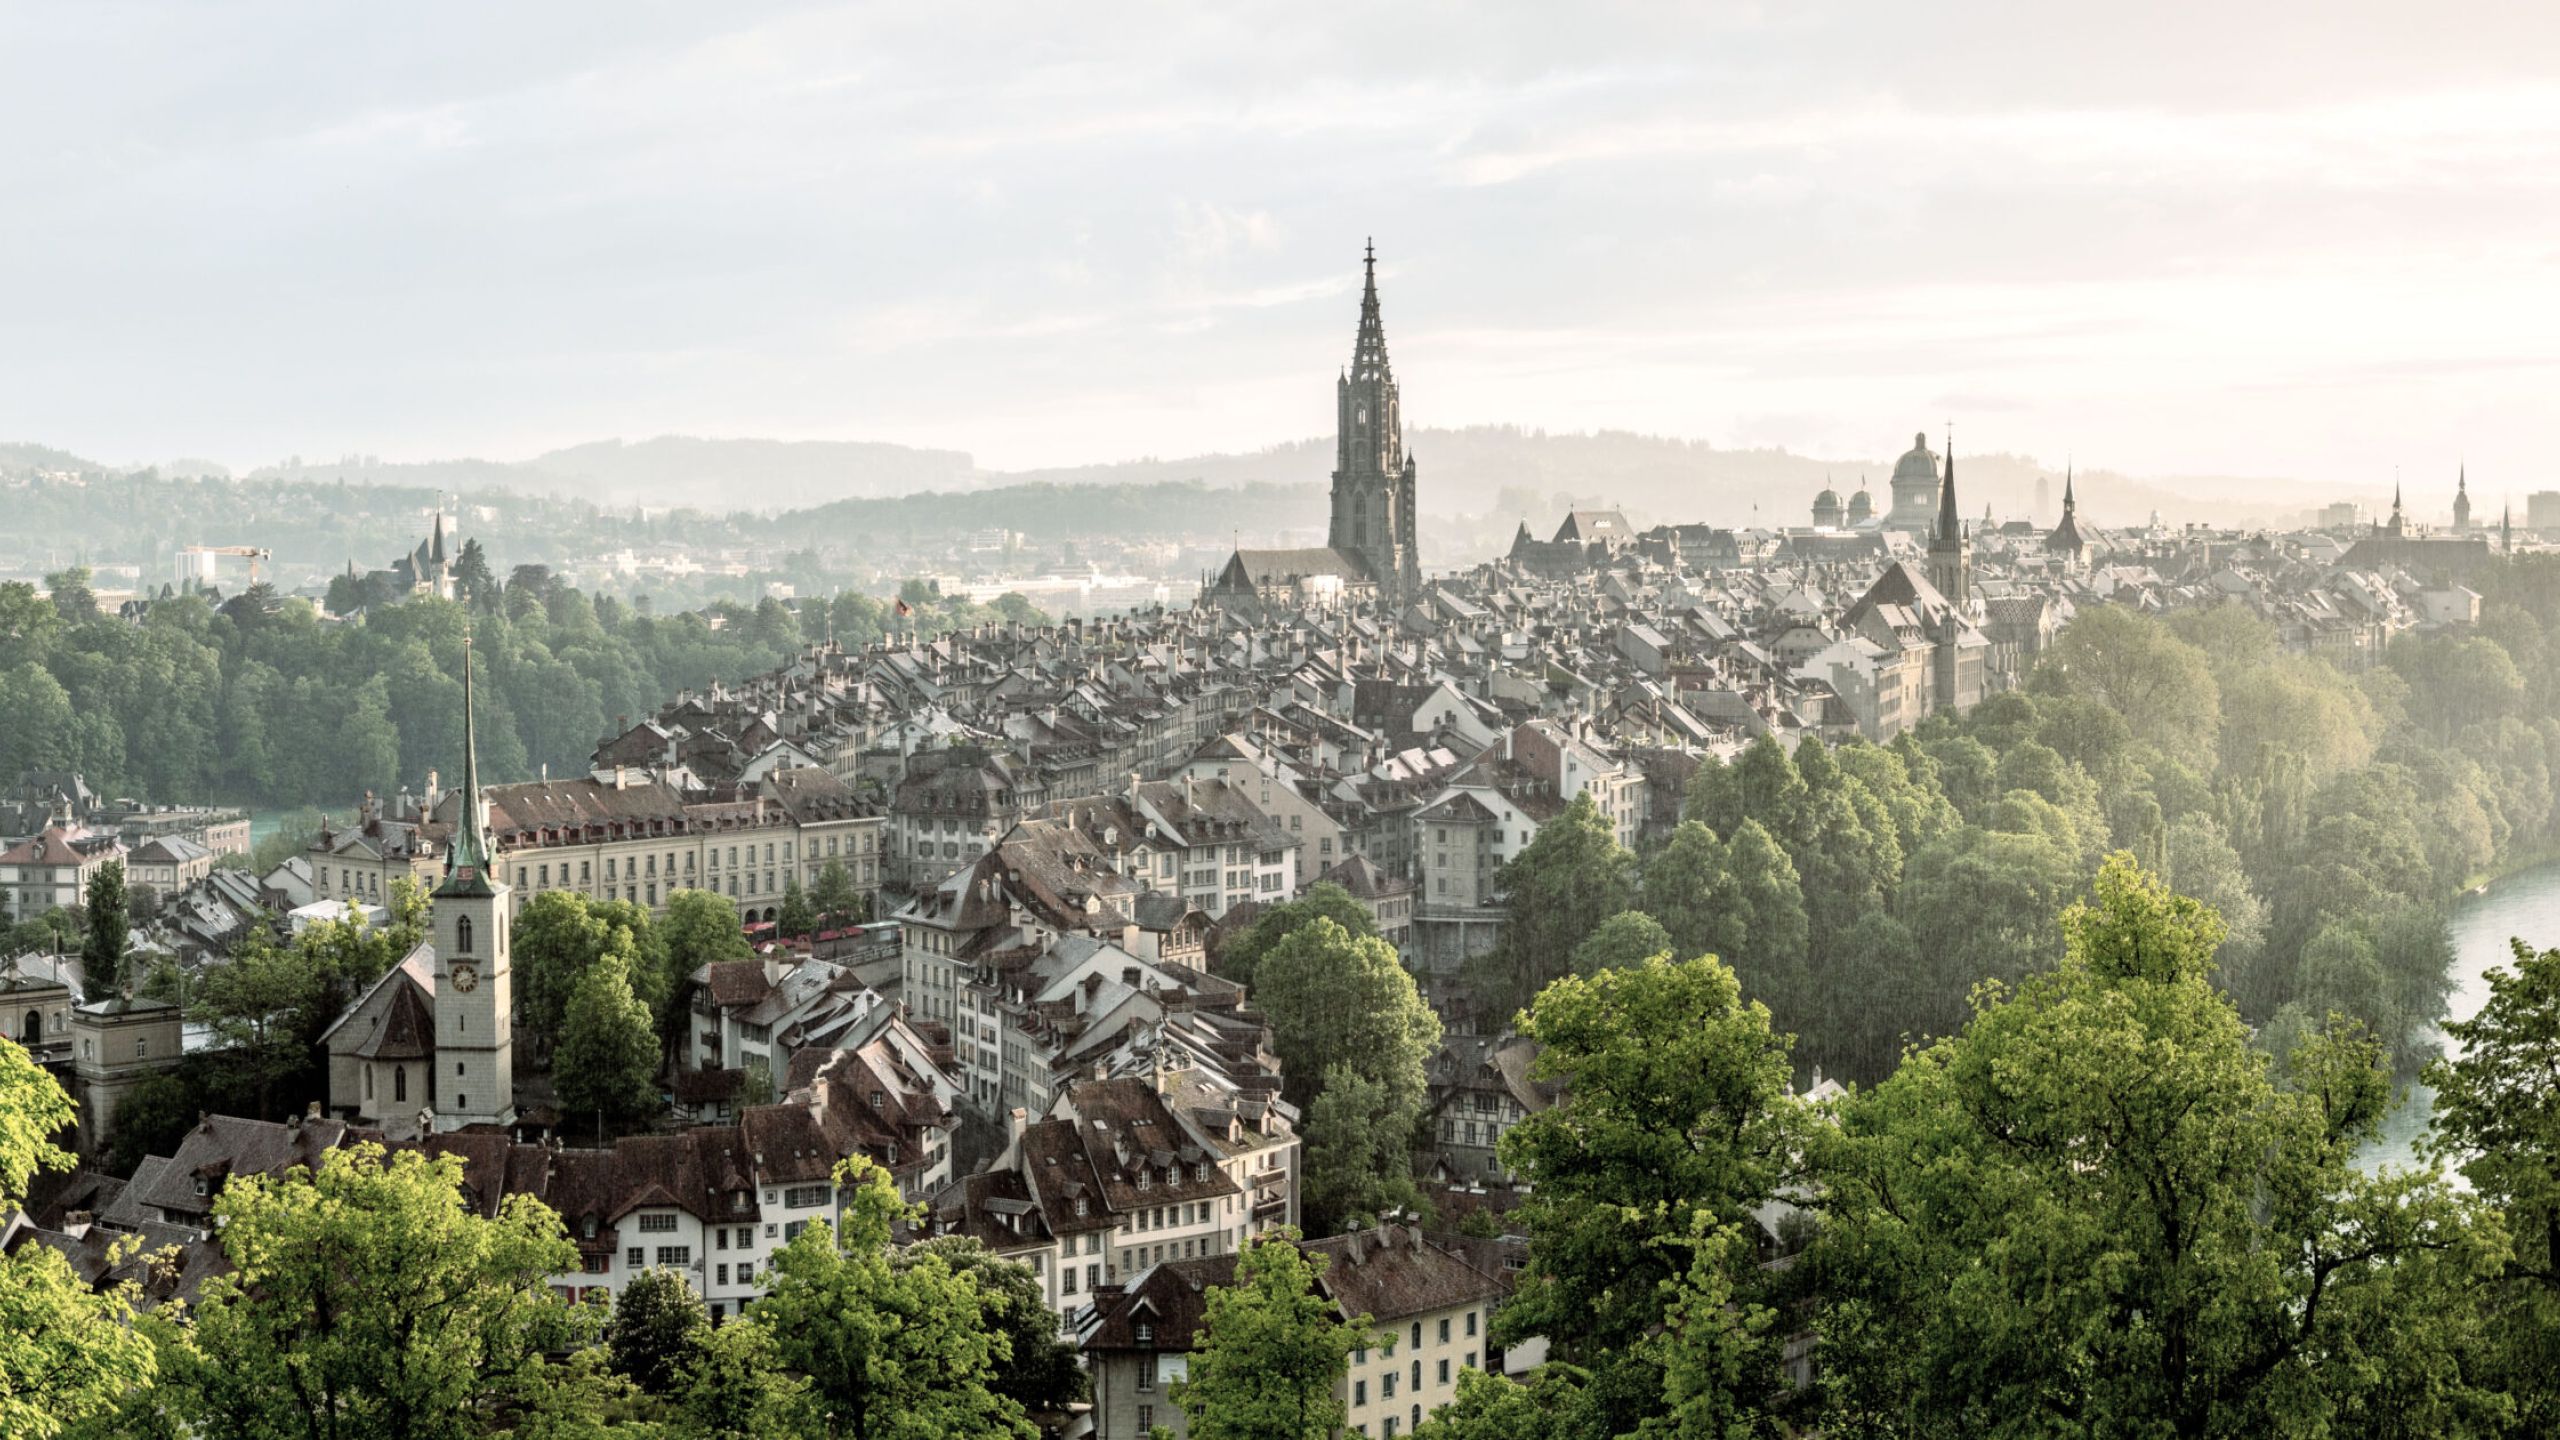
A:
1326,243,1423,600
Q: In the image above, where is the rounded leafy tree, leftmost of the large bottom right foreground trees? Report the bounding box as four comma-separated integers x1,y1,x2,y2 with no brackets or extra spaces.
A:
1492,956,1802,1435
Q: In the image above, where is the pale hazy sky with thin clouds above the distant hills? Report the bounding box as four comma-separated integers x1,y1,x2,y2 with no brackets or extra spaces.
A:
0,0,2560,495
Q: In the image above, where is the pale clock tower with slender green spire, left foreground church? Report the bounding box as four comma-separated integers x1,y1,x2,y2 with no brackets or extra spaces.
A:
435,635,515,1130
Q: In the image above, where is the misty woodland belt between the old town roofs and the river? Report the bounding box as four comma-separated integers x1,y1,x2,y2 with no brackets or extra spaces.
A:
1477,576,2560,1081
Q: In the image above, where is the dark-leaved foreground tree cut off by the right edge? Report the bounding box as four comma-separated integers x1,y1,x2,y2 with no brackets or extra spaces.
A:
2427,940,2560,1435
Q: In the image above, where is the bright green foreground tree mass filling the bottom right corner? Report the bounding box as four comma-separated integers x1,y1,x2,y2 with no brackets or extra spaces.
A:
1418,853,2560,1440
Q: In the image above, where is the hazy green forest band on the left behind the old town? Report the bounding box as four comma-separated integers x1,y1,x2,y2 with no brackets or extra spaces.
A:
0,566,1044,807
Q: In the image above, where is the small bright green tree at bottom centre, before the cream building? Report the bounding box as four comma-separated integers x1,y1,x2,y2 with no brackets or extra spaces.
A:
1170,1227,1380,1440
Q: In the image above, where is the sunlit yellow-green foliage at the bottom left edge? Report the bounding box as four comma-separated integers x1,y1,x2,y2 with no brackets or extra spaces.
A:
0,1038,159,1440
